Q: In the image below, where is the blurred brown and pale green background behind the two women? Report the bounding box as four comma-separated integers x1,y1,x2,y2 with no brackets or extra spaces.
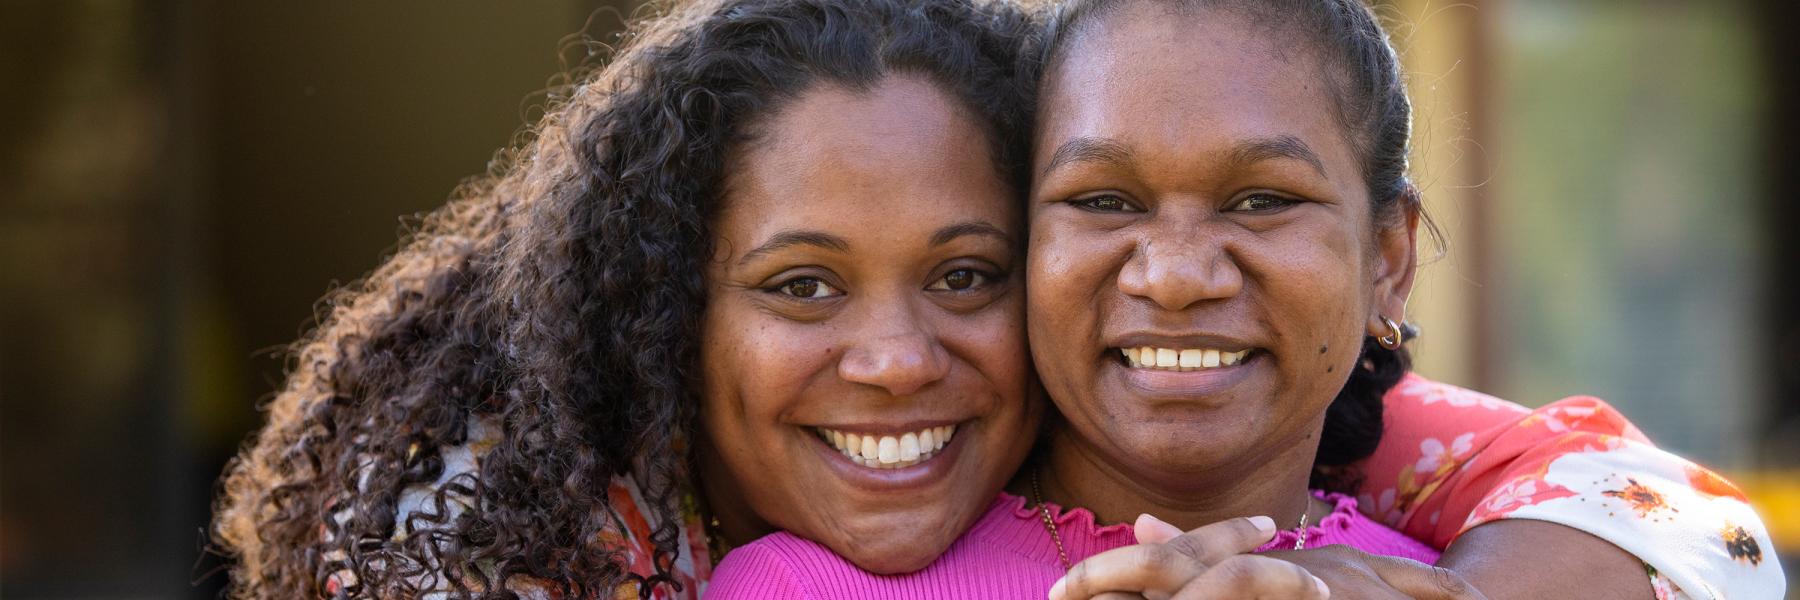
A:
0,0,1800,598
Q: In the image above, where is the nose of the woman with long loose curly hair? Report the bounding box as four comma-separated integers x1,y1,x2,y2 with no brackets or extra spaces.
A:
837,323,950,396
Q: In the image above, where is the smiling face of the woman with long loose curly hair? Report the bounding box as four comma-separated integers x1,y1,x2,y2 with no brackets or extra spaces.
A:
700,76,1040,573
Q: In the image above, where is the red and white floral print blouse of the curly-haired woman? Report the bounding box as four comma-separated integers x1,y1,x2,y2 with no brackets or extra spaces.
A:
383,375,1786,600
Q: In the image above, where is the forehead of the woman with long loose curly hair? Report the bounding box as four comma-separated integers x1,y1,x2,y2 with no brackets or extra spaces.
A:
720,76,1017,236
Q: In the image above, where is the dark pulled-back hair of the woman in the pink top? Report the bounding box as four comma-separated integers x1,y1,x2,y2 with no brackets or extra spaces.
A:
1037,0,1436,490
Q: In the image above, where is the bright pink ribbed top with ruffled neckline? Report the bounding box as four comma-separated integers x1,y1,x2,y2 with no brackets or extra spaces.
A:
706,492,1438,598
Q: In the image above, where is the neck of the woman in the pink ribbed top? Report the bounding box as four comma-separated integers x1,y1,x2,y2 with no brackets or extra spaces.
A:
1013,419,1328,532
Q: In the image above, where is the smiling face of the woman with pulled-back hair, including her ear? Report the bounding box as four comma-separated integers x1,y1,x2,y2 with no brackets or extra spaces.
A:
1028,2,1413,492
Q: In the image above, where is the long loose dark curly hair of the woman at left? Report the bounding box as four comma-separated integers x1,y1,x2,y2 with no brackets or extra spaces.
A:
214,0,1035,598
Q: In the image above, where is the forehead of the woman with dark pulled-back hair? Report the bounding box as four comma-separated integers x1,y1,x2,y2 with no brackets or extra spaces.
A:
1035,2,1355,178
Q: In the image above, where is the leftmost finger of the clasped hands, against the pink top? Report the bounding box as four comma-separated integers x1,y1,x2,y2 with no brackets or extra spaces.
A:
1049,544,1206,600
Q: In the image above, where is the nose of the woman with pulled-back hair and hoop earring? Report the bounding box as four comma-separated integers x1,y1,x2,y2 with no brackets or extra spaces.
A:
1118,227,1244,310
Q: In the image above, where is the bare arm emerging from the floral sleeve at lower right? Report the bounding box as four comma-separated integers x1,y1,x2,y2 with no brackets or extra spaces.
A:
1438,519,1654,600
